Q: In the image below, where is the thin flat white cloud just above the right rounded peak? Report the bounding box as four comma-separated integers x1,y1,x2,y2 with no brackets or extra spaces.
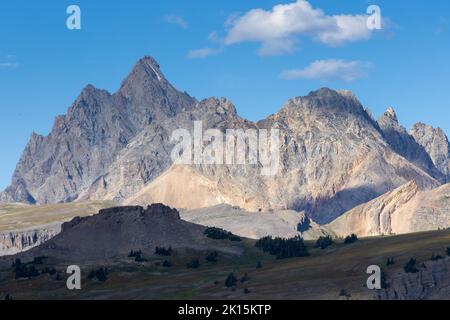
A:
280,59,372,82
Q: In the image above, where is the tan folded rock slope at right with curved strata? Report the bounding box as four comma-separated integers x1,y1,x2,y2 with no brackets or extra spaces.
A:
327,181,450,237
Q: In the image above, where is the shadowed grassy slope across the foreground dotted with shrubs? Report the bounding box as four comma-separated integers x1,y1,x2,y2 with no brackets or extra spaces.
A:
0,230,450,299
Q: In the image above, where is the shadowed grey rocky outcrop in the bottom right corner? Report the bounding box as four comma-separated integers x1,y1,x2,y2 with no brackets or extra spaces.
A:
376,259,450,300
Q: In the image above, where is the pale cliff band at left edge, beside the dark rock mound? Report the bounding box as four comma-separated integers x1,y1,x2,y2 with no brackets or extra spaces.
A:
0,223,61,256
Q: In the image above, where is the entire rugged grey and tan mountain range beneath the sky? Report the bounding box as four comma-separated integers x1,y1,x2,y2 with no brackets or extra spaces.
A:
0,57,450,223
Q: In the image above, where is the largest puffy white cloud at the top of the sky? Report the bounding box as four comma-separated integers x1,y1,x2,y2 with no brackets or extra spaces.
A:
224,0,371,55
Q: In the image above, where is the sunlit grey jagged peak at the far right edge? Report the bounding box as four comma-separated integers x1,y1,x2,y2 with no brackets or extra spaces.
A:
411,123,450,182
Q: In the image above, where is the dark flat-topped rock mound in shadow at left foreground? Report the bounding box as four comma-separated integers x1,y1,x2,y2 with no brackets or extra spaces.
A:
2,204,215,264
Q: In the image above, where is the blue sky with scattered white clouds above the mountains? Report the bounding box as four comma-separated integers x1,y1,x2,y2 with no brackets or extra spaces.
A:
0,0,450,189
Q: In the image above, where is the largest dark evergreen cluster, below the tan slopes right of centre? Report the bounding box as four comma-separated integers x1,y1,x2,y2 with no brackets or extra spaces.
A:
256,237,309,259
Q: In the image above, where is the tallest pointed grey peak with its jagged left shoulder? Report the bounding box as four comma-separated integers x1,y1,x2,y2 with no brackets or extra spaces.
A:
0,57,196,204
